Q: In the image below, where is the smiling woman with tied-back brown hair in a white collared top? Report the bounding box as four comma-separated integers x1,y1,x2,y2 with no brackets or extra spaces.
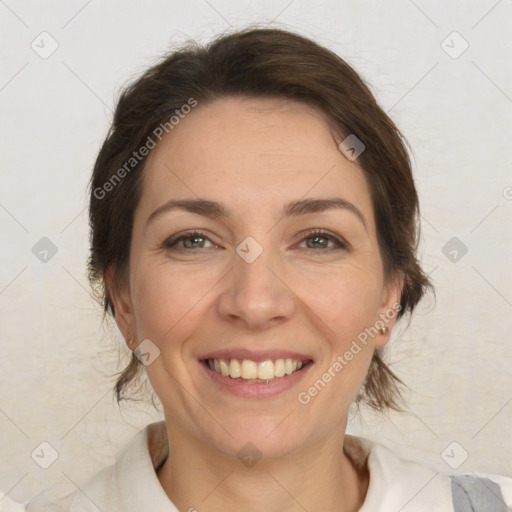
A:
9,29,512,512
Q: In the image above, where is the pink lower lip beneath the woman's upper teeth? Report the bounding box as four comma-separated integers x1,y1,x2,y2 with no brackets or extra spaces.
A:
200,361,313,398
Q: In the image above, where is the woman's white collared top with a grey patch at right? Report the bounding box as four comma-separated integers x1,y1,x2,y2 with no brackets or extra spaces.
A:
4,421,512,512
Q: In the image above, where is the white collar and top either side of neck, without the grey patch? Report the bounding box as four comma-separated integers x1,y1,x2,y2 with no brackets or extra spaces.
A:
70,421,453,512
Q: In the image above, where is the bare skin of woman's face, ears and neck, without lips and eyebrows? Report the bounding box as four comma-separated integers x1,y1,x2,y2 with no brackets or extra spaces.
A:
107,98,403,512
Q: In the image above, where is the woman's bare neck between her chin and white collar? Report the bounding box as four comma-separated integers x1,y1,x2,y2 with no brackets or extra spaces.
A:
157,422,369,512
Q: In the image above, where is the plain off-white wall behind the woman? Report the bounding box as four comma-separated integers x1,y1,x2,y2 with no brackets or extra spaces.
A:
0,0,512,501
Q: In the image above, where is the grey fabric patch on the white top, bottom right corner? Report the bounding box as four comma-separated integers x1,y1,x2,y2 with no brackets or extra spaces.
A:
450,475,511,512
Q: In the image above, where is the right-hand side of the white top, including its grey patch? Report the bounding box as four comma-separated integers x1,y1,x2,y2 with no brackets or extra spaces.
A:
347,436,512,512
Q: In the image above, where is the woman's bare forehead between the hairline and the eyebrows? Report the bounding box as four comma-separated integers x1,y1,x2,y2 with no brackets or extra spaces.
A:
141,98,372,224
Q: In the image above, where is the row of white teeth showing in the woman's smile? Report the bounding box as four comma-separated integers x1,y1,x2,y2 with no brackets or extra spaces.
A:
202,358,313,383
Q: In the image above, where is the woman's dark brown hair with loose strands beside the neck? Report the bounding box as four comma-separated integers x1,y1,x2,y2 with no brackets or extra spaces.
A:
89,28,432,410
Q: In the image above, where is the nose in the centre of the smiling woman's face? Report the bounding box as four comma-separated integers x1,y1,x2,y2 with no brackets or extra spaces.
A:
218,241,296,330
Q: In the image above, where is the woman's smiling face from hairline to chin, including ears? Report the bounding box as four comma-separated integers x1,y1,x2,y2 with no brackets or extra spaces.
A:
114,98,401,457
